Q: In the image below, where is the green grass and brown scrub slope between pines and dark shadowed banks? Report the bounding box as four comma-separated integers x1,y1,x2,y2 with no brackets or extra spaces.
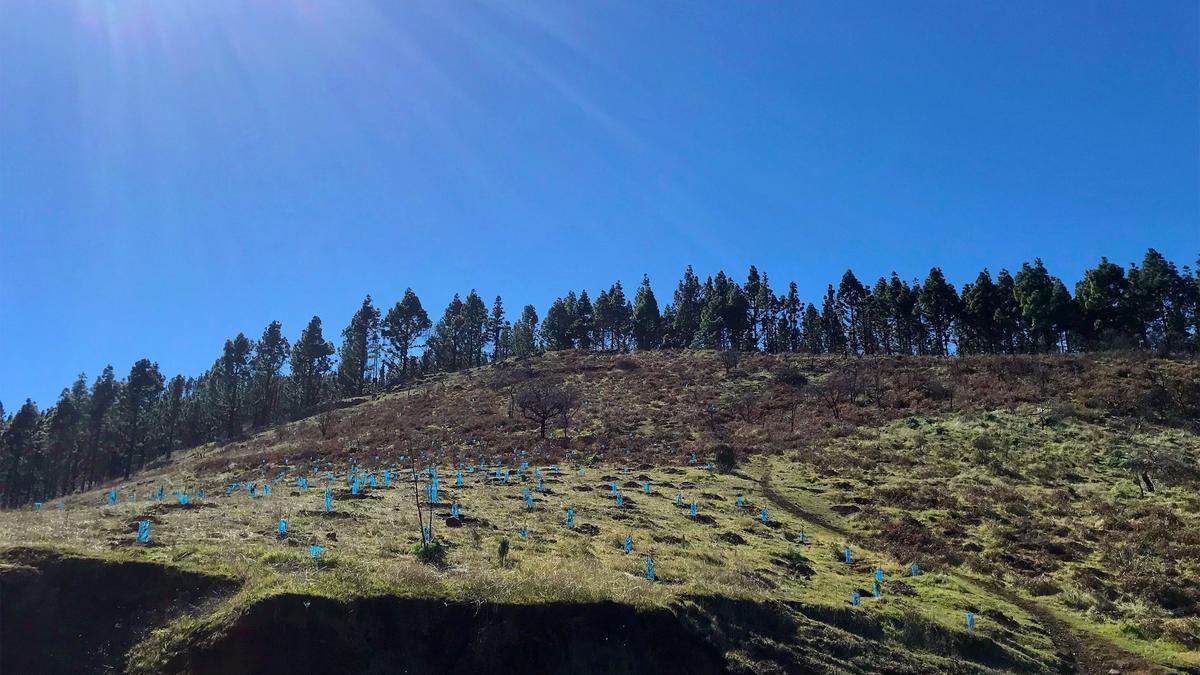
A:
0,354,1200,670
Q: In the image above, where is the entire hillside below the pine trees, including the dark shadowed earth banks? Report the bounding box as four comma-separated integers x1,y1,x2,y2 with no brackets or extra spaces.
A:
0,351,1200,673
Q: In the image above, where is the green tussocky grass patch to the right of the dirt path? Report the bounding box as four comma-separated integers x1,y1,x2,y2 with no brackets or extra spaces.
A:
772,407,1200,668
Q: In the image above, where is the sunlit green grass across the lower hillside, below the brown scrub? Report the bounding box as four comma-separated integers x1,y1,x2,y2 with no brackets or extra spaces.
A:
0,396,1200,671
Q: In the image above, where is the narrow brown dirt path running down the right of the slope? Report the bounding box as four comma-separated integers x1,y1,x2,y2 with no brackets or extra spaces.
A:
758,468,1171,675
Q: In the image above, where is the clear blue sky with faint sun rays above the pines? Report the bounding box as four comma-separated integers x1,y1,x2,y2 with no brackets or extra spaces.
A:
0,0,1200,403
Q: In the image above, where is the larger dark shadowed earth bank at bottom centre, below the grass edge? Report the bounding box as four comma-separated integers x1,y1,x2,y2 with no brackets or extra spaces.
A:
162,595,725,675
